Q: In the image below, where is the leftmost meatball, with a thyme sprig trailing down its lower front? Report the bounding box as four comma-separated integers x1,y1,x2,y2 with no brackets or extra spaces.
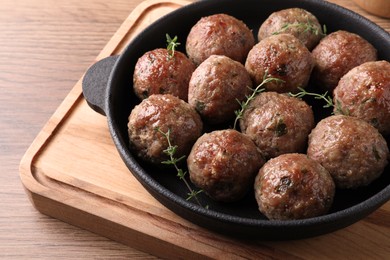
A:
128,94,203,164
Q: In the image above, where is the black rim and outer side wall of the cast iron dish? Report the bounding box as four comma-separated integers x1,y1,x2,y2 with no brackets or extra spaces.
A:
101,0,390,240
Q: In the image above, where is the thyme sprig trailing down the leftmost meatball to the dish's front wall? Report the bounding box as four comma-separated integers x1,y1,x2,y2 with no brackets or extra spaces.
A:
156,128,203,206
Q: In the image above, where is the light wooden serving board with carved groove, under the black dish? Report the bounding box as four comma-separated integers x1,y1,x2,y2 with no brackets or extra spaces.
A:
20,0,390,259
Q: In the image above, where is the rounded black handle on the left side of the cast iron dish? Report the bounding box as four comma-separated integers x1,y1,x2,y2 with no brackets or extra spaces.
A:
82,55,119,116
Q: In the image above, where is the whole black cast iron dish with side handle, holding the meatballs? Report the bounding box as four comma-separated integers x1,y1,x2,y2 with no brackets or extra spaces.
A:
83,0,390,240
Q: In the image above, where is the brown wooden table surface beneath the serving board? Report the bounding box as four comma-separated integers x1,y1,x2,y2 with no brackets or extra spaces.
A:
0,0,390,259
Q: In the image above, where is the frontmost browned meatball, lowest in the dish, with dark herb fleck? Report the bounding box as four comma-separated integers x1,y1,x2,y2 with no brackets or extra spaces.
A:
254,153,335,220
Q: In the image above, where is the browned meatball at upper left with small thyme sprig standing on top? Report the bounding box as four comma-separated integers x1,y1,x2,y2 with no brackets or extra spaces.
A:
133,49,195,101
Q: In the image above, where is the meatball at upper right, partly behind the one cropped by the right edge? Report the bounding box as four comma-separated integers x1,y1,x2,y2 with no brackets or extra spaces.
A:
312,31,377,92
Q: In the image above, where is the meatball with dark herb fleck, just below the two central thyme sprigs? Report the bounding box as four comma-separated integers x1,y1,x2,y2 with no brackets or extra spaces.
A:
240,92,314,159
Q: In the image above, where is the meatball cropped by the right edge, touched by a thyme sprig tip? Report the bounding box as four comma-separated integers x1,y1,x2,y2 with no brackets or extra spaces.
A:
334,61,390,135
